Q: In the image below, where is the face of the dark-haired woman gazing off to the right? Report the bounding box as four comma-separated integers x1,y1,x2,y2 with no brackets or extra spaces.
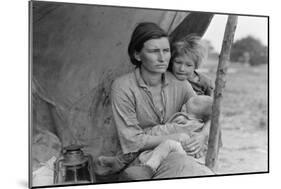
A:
135,37,171,74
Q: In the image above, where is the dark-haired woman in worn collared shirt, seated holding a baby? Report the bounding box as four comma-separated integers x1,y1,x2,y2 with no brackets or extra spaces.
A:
111,23,210,180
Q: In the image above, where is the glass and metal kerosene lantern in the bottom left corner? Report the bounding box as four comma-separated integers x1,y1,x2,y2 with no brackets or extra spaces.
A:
54,145,95,184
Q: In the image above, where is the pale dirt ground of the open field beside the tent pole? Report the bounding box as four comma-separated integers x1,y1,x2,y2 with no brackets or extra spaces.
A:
202,60,268,174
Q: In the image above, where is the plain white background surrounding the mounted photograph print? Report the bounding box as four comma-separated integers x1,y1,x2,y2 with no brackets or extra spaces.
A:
0,0,281,189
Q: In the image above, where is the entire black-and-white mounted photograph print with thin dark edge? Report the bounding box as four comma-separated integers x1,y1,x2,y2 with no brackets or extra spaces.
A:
28,1,269,188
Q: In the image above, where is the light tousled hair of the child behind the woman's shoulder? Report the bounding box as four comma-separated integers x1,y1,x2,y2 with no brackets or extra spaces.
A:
168,34,207,71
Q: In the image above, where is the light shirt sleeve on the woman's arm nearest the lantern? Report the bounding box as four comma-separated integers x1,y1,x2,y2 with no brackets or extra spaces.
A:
111,83,147,154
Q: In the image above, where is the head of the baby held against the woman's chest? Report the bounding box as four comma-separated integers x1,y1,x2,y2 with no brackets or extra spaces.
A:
186,95,213,122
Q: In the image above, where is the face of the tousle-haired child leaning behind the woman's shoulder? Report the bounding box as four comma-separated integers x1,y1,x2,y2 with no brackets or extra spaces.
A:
172,54,195,80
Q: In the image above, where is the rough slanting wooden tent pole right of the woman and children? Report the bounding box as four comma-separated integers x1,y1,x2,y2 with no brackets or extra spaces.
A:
206,15,237,171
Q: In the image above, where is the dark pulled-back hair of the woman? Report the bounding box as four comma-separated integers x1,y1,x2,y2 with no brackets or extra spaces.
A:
128,22,168,67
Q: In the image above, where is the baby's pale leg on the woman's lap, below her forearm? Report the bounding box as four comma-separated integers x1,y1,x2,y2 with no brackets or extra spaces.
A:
144,140,186,171
